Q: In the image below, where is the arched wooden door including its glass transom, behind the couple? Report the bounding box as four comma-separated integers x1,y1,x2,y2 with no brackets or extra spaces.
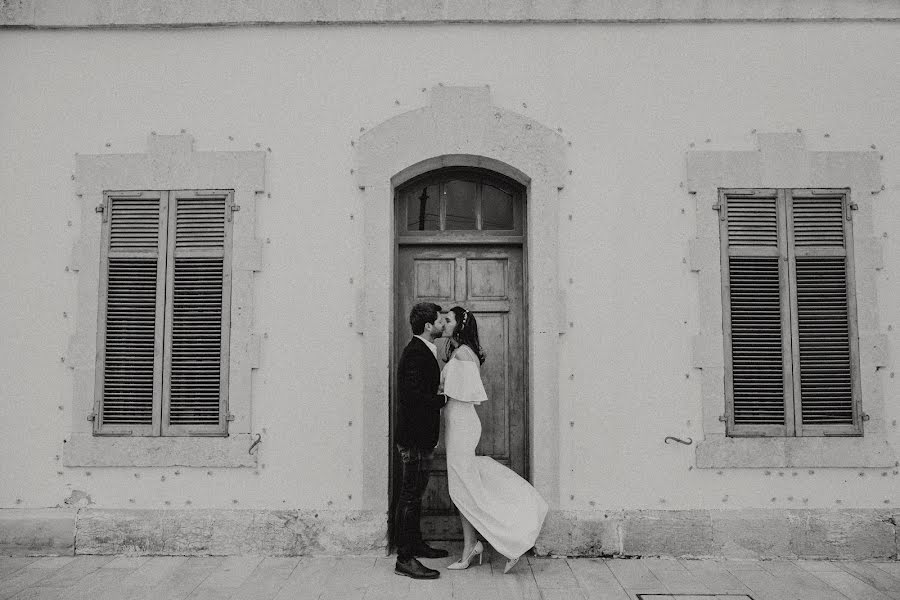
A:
391,169,527,540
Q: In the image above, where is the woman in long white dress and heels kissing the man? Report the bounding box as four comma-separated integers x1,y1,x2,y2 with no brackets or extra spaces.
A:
441,306,547,573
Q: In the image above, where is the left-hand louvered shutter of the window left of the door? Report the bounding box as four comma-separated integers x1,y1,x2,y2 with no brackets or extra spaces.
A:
94,192,168,435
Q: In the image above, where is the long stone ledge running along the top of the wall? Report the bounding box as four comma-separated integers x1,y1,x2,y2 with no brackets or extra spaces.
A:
0,0,900,28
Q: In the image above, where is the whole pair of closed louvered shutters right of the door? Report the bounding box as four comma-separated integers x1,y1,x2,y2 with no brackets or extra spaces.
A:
719,189,862,436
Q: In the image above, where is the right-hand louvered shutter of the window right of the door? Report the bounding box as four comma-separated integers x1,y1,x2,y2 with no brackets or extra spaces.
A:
787,190,862,435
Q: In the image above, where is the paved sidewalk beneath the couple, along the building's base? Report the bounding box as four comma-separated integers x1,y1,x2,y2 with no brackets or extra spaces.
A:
0,550,900,600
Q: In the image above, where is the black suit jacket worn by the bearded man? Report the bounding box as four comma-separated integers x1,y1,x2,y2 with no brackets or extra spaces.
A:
395,337,445,450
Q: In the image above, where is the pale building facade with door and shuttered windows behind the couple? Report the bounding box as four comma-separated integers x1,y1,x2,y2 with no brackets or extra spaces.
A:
0,0,900,558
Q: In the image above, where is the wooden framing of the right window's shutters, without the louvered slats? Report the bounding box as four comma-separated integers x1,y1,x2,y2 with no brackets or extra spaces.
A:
717,188,864,438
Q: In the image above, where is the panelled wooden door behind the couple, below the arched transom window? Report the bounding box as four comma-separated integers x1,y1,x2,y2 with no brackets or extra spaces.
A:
393,245,527,540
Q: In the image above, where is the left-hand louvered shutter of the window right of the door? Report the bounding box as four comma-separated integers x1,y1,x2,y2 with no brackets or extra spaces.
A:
719,190,793,436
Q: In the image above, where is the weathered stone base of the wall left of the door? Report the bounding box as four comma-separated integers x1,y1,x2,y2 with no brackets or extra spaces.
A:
0,508,387,556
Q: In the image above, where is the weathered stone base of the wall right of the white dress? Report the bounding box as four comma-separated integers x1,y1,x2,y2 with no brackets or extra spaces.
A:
535,509,900,560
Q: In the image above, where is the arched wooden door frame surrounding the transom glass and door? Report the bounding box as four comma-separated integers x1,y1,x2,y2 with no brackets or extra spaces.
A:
387,165,532,552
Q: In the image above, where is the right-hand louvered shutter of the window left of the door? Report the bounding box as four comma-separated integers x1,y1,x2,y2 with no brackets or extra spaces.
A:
162,191,234,435
